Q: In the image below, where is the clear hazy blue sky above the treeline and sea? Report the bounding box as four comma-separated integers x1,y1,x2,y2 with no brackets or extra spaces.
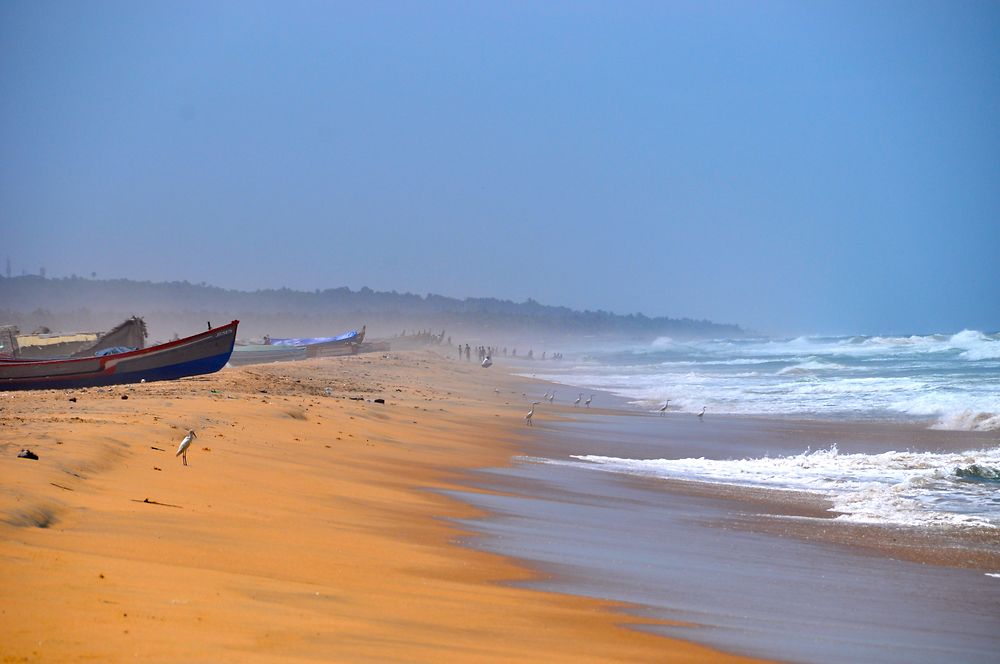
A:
0,0,1000,333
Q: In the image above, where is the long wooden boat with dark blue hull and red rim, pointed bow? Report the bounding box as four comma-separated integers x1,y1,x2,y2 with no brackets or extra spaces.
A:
0,320,239,390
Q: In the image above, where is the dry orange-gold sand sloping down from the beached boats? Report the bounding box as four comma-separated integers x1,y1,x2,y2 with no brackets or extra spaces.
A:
0,351,752,662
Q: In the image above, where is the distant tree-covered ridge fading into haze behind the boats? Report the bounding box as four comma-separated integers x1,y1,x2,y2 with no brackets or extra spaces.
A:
0,276,744,343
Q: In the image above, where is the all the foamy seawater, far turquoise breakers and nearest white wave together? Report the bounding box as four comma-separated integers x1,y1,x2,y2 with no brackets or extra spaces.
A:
530,330,1000,528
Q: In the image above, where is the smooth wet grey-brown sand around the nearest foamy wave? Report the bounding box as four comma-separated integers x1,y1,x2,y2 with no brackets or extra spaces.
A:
459,397,1000,662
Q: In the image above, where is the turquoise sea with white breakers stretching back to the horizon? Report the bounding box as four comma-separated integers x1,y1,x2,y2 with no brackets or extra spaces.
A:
528,330,1000,431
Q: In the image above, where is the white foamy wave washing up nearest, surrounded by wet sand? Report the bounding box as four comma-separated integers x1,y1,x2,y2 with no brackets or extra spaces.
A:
573,447,1000,528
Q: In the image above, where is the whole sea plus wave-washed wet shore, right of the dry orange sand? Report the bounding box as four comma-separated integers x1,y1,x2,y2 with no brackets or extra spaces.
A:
455,331,1000,664
